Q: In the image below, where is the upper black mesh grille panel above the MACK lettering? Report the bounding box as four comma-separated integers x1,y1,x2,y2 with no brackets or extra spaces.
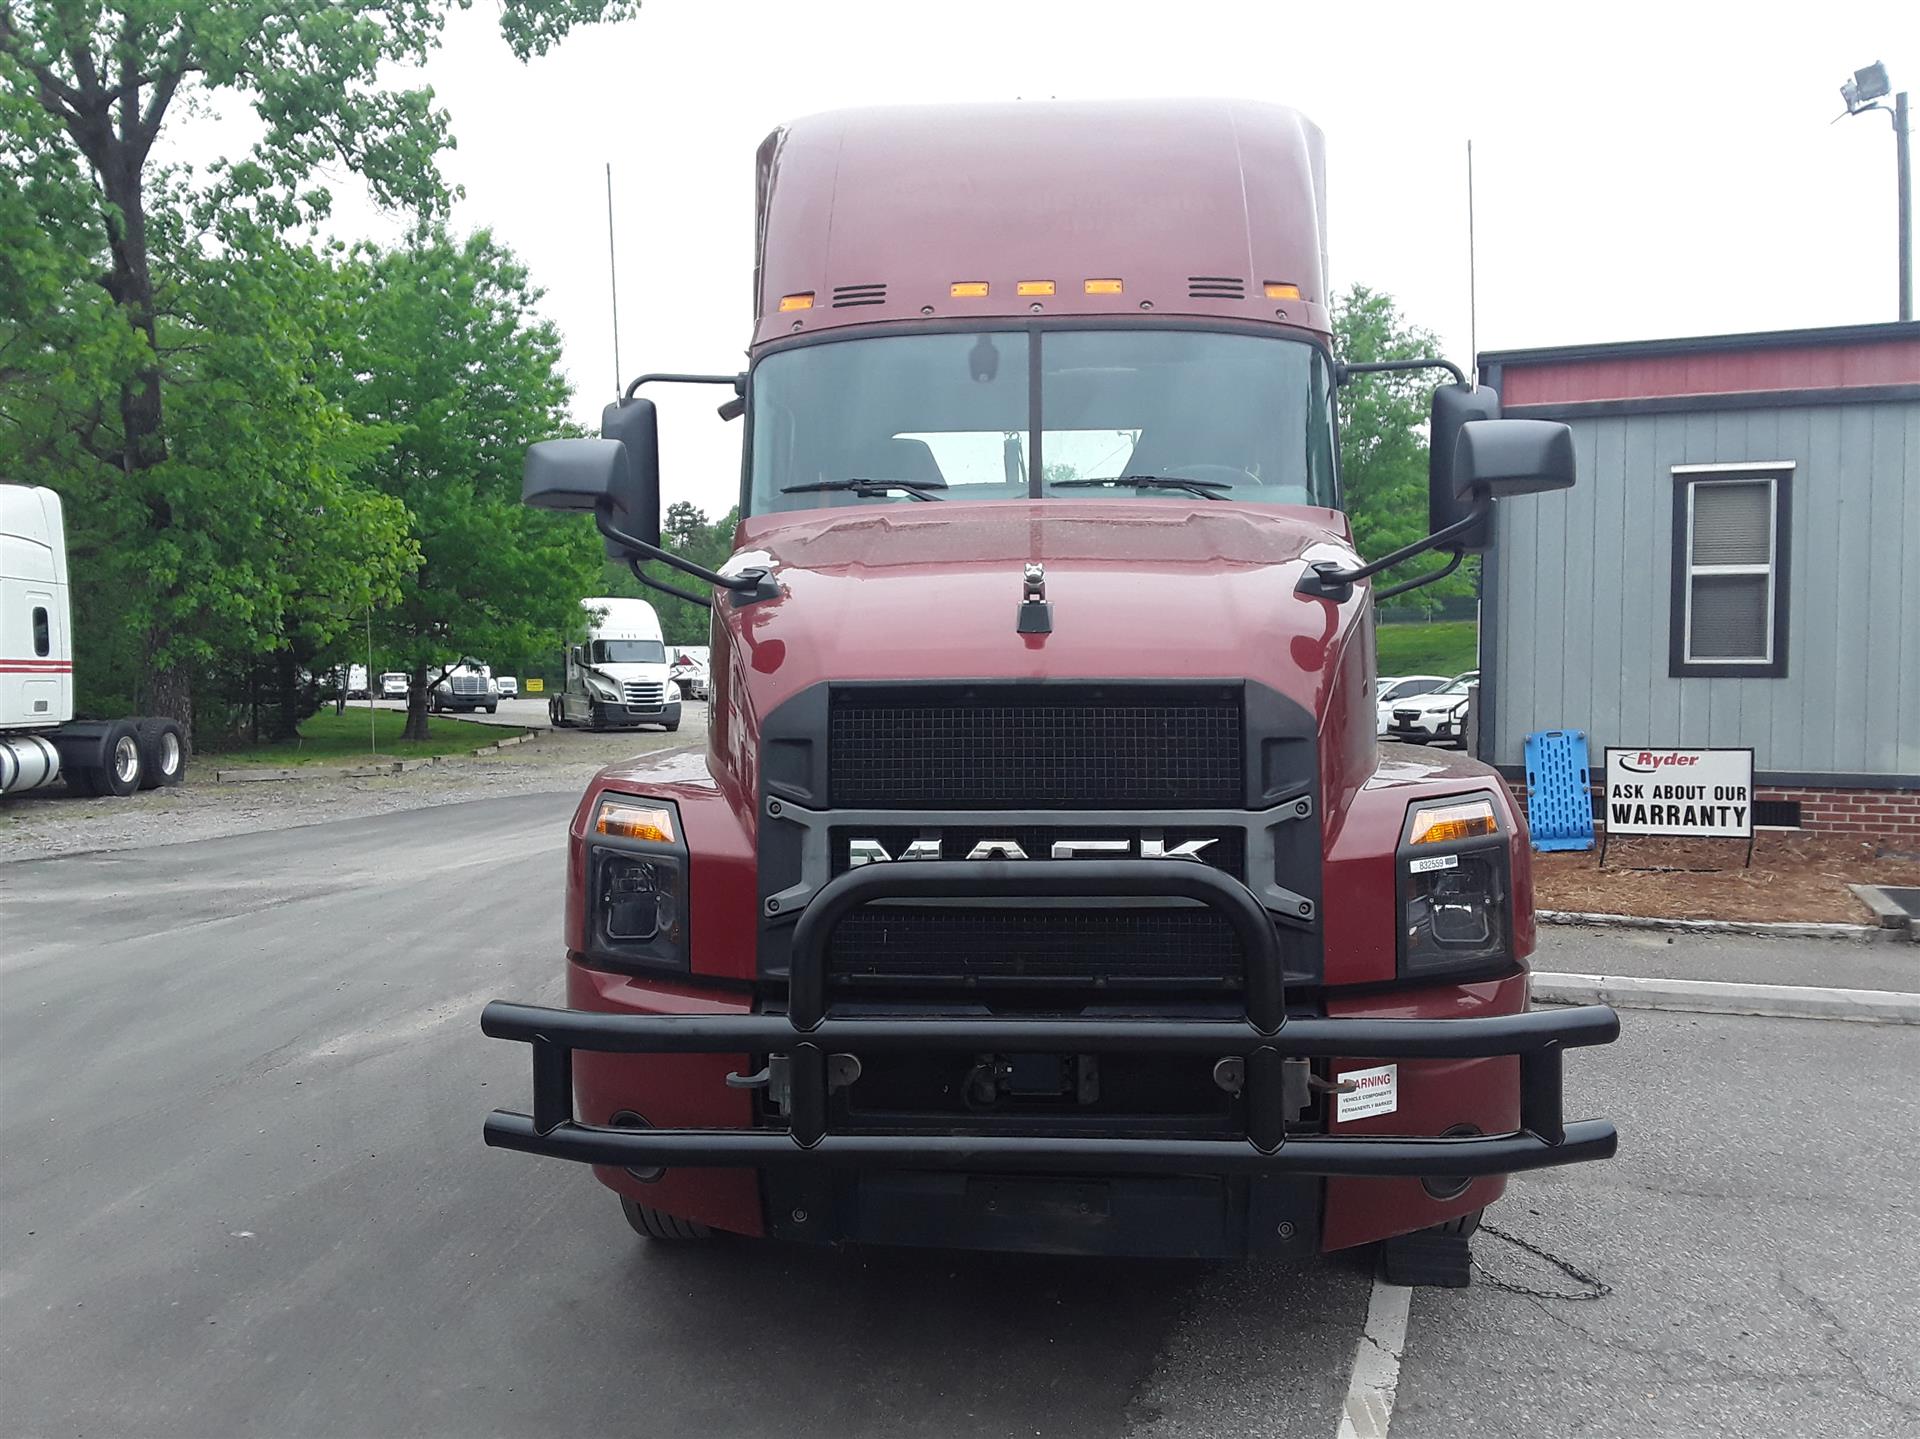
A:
828,688,1246,811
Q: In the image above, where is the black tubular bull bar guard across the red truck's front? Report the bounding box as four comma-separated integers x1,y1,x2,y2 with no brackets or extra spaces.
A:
480,859,1620,1178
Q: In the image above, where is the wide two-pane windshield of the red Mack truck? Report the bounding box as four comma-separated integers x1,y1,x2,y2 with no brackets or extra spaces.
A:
747,329,1338,513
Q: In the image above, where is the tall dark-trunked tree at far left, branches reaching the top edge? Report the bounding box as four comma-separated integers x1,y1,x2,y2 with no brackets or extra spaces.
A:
0,0,639,724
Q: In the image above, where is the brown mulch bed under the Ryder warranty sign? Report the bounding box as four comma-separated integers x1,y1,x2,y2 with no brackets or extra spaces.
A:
1534,832,1920,924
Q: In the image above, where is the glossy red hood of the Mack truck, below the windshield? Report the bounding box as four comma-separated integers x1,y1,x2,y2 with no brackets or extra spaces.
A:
716,498,1373,715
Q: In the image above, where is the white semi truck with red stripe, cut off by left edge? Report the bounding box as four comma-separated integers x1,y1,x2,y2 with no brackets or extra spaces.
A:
0,484,186,795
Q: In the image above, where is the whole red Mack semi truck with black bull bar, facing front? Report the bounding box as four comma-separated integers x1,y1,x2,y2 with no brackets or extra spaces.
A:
482,102,1619,1283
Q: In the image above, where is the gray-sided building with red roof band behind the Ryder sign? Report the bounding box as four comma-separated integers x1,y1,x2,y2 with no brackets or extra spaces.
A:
1478,323,1920,840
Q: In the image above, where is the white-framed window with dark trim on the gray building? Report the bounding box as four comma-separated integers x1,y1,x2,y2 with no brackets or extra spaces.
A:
1668,461,1793,678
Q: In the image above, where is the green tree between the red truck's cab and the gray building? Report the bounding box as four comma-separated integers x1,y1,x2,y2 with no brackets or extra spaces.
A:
1332,284,1478,603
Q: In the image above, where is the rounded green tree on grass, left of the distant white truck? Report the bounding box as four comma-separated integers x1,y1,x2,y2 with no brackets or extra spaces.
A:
323,229,601,738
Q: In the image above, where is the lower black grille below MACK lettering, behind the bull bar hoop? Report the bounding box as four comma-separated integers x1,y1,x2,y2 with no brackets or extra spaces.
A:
828,905,1242,989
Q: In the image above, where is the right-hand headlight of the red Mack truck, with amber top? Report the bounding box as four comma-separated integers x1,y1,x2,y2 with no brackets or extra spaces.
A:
1396,795,1513,978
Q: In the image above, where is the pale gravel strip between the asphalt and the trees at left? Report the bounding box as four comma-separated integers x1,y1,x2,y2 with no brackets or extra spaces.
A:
0,703,707,863
